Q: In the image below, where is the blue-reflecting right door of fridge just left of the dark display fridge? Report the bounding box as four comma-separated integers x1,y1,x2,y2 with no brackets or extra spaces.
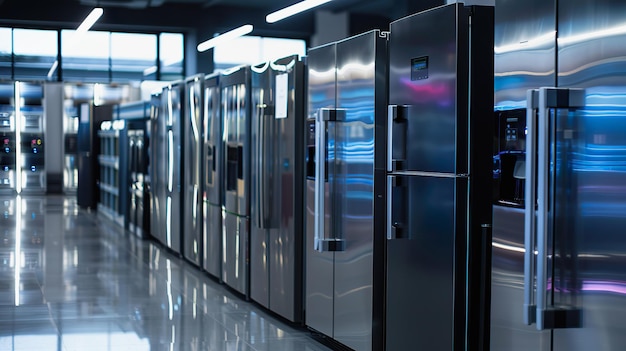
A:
331,31,376,350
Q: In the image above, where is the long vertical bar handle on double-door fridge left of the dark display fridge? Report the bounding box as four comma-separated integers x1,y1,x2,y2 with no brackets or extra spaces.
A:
313,108,345,252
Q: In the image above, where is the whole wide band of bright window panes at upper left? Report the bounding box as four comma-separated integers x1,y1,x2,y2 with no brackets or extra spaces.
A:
0,27,185,83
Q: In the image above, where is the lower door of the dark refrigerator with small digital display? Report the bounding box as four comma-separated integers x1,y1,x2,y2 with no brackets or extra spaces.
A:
386,175,458,350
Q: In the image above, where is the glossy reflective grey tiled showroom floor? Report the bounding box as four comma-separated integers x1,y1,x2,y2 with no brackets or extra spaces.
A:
0,196,328,351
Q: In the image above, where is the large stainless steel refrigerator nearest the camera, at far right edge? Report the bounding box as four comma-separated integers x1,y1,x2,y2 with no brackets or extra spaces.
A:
491,0,626,351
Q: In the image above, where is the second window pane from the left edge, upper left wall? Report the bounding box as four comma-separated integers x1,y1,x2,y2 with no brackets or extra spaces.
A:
13,28,58,80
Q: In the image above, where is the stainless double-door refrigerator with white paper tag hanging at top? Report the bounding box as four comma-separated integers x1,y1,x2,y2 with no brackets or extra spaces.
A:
250,56,306,322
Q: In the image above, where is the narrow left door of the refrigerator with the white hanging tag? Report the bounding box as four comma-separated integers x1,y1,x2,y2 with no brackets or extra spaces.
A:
250,62,276,308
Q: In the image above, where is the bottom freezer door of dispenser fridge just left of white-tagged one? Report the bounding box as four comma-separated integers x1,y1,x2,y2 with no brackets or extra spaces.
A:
222,212,250,296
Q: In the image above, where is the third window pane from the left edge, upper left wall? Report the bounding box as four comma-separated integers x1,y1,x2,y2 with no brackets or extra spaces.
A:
61,30,111,82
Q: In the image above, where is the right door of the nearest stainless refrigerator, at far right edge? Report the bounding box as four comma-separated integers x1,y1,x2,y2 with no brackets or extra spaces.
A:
554,0,626,351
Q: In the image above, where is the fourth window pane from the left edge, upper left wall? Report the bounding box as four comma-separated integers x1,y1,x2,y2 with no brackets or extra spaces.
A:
111,33,157,82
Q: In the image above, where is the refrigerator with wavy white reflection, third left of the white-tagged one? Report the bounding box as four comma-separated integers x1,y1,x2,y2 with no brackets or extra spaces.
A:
181,75,204,267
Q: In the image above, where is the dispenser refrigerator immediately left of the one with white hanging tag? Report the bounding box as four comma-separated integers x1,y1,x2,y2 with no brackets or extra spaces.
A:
220,66,251,297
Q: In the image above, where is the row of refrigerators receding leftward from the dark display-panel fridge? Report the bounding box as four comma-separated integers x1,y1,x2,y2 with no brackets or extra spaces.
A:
149,3,493,350
